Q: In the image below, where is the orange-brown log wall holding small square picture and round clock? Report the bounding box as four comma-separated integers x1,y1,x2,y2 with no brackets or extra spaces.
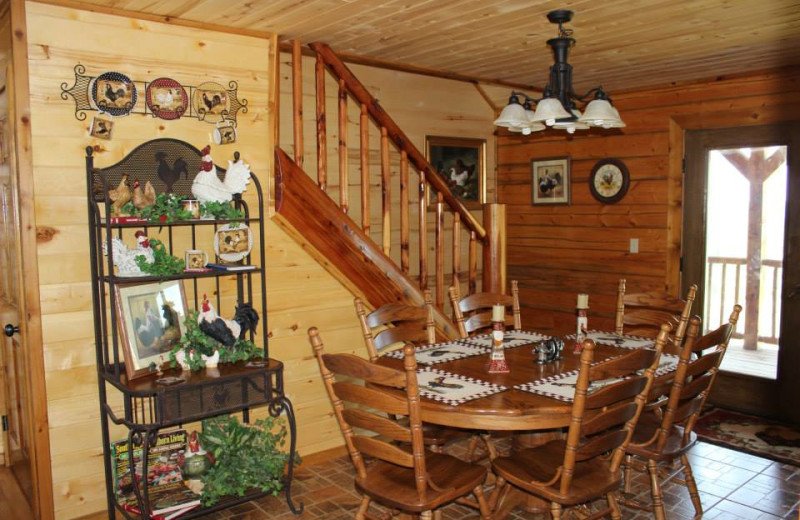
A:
497,69,800,332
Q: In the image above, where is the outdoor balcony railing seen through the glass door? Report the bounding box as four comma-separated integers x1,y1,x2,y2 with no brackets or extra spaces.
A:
705,256,783,349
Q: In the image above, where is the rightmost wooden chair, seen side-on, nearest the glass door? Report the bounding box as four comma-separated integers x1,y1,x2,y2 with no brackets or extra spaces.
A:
625,305,742,520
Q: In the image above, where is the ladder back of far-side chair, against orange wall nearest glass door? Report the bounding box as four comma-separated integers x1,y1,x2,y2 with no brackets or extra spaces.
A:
616,278,697,354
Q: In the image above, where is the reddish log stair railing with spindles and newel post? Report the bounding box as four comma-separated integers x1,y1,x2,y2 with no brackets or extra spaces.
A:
292,41,505,309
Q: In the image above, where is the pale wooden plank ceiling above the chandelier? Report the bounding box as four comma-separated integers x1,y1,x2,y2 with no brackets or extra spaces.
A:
70,0,800,93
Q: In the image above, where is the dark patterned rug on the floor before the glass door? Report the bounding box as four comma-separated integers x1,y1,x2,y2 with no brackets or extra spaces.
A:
694,408,800,466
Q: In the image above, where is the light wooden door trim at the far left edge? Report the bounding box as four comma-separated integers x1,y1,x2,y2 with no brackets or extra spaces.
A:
9,0,55,520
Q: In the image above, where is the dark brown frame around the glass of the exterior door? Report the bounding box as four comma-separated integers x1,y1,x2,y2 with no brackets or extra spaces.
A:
682,122,800,421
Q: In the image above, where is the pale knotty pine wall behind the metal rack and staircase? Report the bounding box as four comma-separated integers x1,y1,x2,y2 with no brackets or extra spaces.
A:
20,2,494,519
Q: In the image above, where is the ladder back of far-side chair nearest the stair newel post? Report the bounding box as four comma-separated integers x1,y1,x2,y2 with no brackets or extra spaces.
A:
449,280,522,338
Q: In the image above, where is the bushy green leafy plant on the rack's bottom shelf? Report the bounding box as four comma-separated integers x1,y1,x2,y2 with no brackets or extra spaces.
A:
199,416,300,506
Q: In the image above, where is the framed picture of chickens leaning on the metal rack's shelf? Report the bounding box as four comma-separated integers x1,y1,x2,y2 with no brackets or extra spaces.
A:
115,280,187,379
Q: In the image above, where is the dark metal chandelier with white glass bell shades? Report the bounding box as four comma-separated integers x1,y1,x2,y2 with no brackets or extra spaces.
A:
494,9,625,135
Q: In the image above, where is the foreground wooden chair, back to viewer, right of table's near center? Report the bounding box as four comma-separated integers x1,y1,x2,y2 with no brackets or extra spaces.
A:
490,324,671,520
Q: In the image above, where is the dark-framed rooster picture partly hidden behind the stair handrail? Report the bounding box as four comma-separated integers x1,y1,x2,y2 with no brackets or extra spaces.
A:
425,135,486,207
